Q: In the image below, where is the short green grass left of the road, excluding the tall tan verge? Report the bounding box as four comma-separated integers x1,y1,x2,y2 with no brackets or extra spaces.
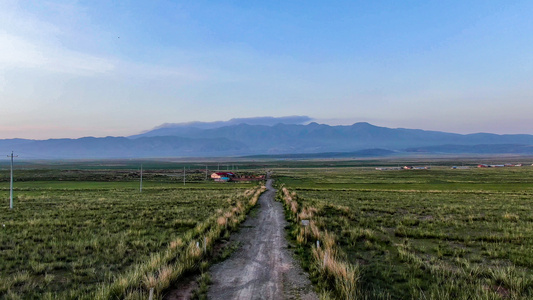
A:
0,170,255,299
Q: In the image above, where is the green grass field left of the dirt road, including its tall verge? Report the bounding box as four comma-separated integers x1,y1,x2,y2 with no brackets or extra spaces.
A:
0,170,264,299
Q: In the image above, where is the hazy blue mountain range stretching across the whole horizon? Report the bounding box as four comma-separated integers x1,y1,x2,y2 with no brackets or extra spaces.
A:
0,116,533,159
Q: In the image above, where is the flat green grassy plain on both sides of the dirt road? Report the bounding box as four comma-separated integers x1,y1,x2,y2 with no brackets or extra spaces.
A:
4,160,533,299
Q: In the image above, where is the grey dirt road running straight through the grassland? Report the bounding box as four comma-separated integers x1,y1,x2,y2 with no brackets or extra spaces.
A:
208,179,318,300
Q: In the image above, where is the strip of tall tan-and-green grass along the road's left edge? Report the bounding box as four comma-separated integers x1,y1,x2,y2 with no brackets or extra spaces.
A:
90,186,265,300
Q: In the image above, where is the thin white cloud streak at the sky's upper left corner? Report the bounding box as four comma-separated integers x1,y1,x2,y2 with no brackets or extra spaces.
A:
0,1,206,81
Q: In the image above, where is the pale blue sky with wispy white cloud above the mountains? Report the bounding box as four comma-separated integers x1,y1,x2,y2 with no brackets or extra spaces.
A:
0,0,533,139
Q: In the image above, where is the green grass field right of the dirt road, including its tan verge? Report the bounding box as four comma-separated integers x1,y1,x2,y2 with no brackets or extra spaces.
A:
277,167,533,299
